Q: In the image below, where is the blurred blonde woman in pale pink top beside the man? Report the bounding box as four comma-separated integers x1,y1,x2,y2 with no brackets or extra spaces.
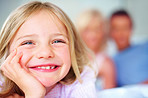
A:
76,10,116,90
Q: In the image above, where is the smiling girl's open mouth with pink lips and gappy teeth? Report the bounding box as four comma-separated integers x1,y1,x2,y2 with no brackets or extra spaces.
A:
29,64,61,72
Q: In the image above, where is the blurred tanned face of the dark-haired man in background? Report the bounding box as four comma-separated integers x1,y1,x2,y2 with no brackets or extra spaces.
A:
110,16,132,51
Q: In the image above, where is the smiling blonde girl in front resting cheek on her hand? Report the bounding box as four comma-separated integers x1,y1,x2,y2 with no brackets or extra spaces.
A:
0,1,96,98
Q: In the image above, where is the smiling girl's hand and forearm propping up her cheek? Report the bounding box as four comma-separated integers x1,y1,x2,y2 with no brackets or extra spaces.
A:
1,50,46,98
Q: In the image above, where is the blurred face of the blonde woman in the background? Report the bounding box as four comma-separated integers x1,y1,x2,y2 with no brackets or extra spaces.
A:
81,18,104,53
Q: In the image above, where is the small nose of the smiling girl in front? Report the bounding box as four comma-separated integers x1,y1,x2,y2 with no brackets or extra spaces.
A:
36,46,54,59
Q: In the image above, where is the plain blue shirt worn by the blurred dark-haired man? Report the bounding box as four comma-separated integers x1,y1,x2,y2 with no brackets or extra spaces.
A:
114,42,148,86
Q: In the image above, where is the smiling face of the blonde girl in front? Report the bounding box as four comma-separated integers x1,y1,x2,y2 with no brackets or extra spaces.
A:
9,10,71,87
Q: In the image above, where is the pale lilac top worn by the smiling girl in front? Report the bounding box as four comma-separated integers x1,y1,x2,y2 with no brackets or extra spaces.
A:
45,66,96,98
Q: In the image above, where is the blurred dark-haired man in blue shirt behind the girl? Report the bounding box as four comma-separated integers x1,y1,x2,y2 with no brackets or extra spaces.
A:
110,10,148,86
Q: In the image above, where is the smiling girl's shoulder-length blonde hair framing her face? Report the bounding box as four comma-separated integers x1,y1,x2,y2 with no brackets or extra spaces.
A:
0,1,89,97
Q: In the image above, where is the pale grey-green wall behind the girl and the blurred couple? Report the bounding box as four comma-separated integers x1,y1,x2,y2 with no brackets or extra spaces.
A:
0,0,148,44
